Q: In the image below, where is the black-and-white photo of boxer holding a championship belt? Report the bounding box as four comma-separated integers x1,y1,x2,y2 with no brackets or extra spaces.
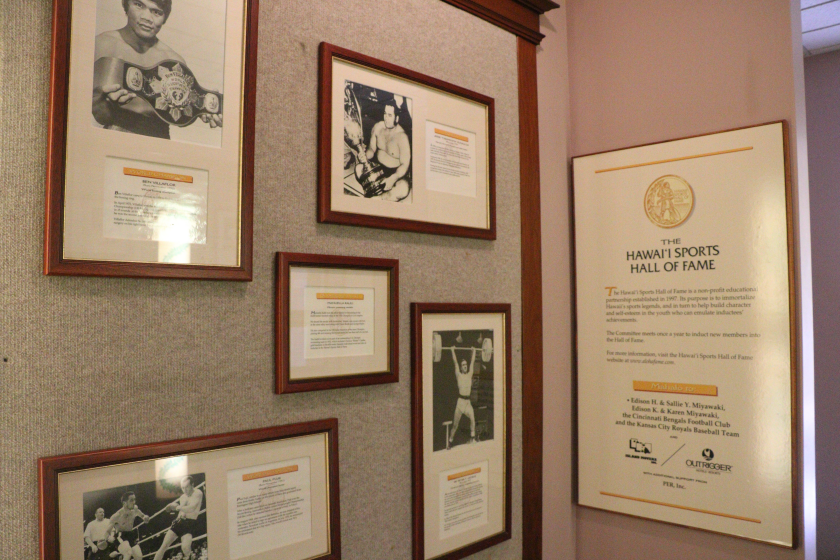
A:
92,0,227,147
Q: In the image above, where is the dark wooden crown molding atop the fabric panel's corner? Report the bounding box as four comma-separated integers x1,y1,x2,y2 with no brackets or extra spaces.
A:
443,0,560,45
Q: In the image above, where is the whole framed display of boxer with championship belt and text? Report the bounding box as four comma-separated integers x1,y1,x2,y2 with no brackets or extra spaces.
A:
44,0,258,280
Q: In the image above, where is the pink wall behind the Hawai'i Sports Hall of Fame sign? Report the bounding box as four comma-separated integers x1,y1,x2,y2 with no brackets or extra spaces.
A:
564,0,812,560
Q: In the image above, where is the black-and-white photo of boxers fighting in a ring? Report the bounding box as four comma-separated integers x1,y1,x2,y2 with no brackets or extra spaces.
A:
82,468,209,560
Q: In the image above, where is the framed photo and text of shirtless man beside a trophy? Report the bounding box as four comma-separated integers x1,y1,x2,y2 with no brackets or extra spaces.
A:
318,43,496,239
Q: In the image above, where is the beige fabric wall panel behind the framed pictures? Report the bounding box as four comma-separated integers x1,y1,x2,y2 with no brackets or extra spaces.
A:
0,0,522,560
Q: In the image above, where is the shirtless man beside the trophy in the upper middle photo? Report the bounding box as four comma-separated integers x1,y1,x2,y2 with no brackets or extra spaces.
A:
365,99,411,202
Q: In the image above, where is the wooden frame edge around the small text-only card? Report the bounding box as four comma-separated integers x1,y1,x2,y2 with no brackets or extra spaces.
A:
274,252,400,395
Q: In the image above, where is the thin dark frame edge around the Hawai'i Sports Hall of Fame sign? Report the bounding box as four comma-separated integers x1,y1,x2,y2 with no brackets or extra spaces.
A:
569,119,801,550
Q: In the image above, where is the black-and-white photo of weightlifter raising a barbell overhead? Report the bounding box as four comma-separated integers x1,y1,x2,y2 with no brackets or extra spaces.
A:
432,329,494,451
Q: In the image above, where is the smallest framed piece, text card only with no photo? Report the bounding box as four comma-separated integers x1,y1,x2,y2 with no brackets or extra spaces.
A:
275,253,399,394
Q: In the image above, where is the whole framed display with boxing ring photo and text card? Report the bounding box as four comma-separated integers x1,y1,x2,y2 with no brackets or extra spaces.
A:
38,418,341,560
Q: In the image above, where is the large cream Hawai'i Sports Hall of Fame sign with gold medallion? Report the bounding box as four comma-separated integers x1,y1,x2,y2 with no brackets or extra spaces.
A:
573,122,797,547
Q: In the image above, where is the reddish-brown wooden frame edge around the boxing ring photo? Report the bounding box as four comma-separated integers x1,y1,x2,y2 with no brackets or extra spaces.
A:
38,418,341,560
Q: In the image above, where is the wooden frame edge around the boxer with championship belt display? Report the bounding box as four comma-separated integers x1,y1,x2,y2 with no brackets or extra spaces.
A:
43,0,259,281
